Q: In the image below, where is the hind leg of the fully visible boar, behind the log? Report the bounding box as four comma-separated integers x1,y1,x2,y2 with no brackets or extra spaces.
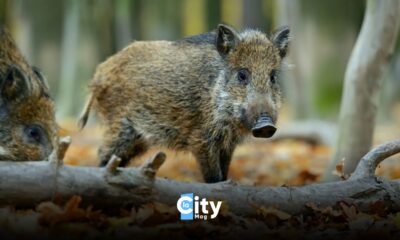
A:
99,118,147,167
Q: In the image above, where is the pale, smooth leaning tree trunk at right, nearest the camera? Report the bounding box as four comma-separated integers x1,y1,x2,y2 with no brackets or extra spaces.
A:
324,0,400,180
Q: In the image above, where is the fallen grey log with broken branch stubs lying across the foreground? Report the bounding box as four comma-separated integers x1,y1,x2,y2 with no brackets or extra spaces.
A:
0,139,400,216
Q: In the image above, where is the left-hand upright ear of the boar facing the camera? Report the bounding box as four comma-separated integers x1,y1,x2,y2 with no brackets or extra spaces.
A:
217,24,239,56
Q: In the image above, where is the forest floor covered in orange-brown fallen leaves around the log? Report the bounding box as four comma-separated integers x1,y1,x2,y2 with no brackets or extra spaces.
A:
0,109,400,239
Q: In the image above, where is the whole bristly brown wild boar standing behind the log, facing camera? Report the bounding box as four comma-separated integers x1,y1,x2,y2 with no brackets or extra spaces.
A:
79,24,289,183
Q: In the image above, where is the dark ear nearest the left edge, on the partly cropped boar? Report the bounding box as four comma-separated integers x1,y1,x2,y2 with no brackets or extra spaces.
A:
0,65,30,101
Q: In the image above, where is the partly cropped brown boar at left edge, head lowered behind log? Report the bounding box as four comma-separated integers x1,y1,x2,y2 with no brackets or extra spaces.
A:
0,26,57,161
